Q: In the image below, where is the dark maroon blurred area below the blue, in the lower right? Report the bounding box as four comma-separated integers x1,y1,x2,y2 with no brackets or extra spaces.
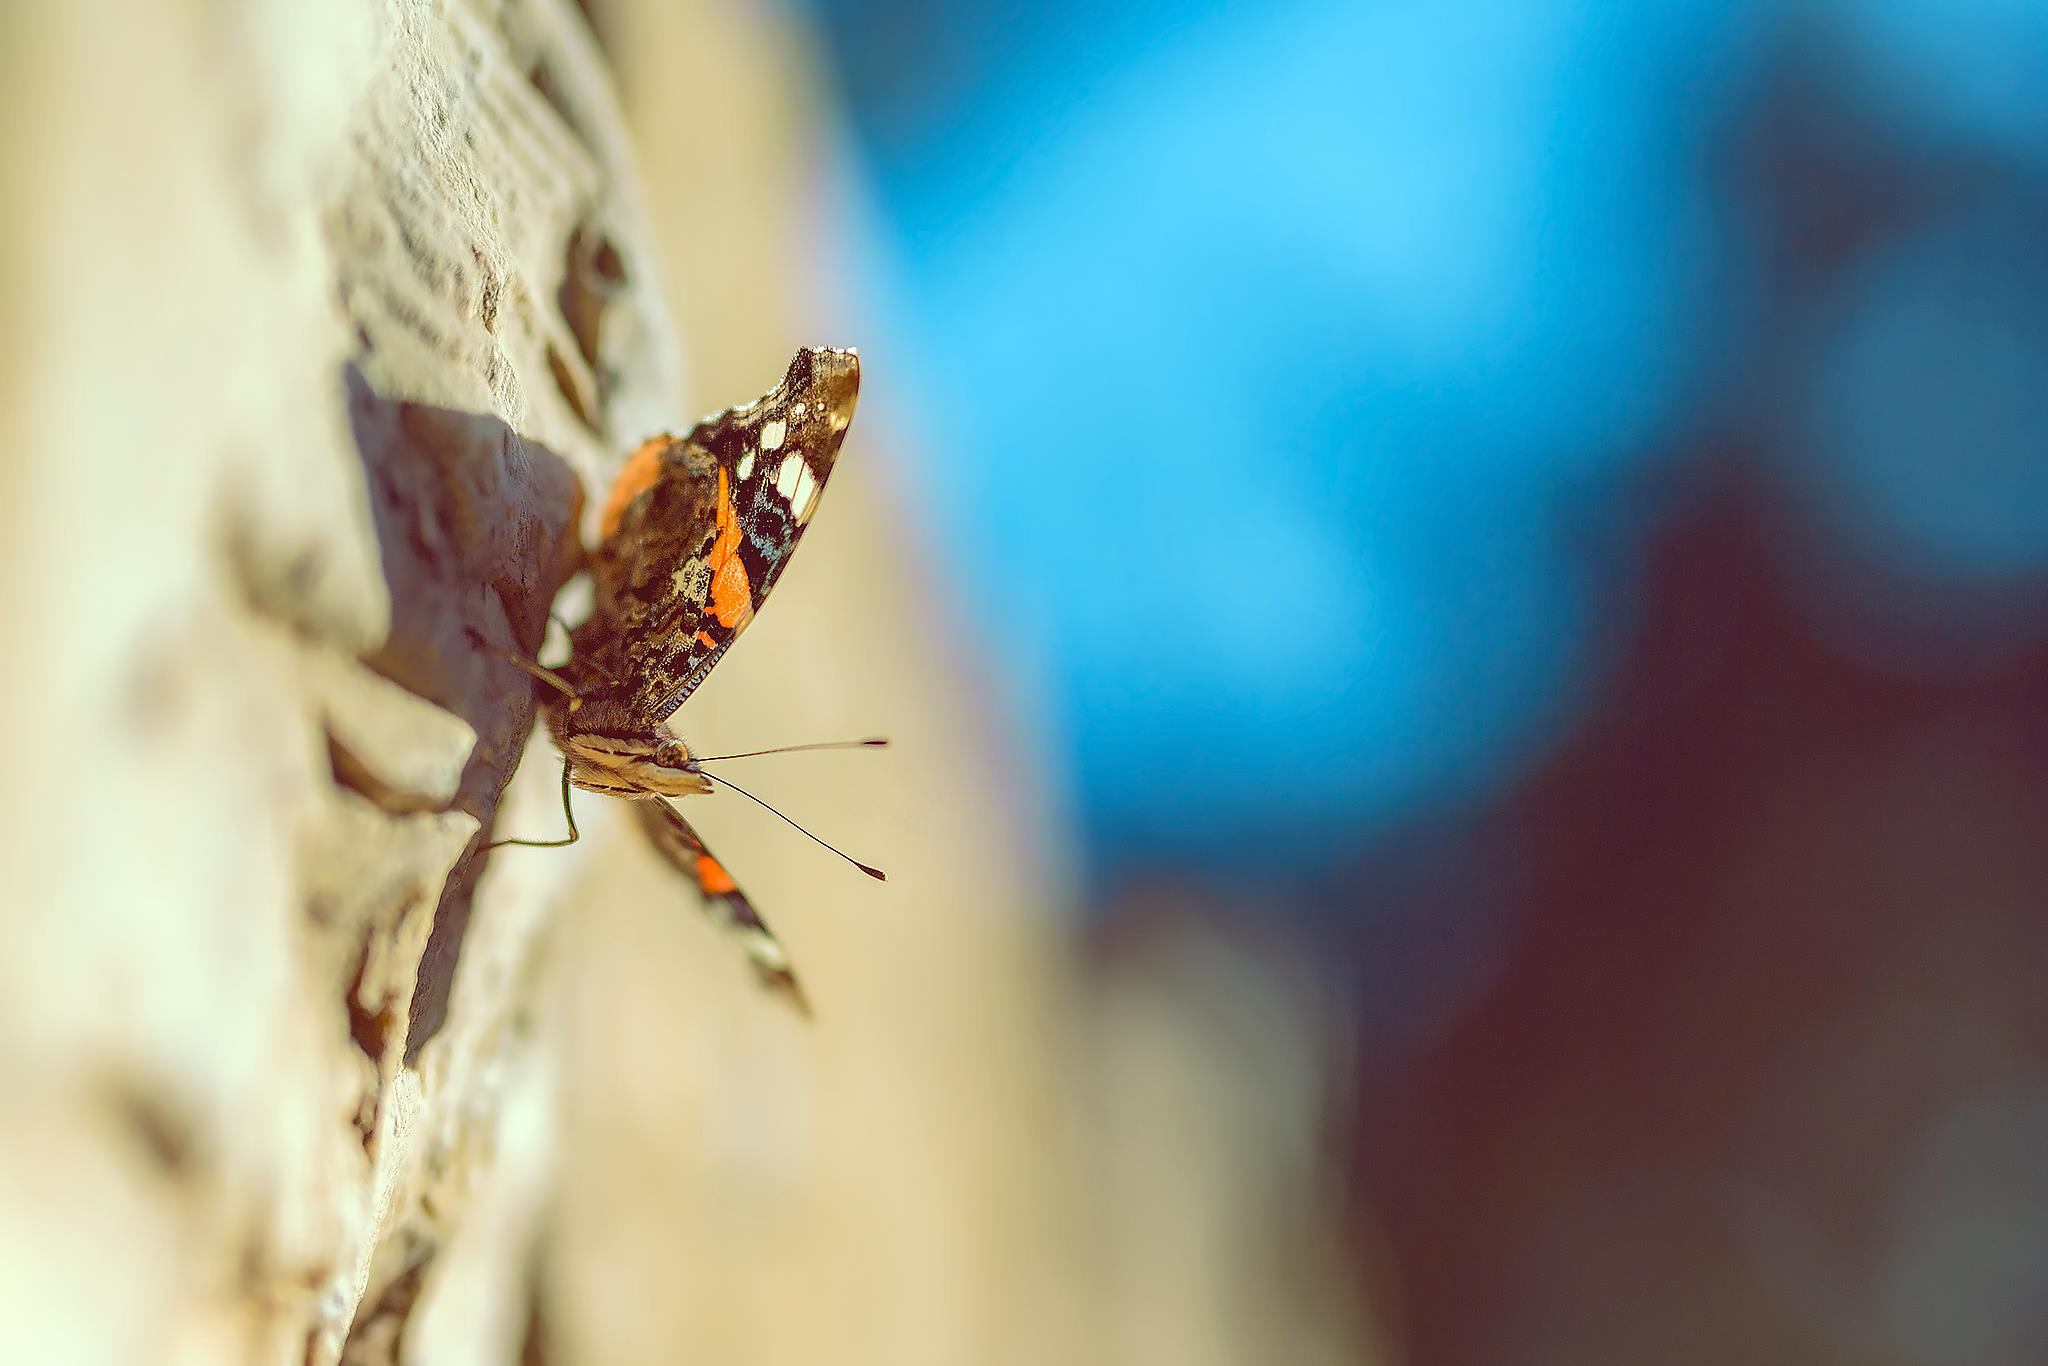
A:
1350,487,2048,1364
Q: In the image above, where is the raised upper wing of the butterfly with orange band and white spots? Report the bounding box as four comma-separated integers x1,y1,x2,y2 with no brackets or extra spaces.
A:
580,348,860,723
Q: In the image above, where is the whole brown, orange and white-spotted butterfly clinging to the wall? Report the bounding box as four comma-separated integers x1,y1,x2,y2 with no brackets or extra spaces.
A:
494,348,885,1010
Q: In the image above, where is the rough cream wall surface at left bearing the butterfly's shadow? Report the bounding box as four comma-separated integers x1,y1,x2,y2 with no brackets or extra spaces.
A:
0,0,682,1362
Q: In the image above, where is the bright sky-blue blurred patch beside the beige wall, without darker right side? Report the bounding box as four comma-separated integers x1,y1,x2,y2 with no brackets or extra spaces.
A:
794,0,2048,870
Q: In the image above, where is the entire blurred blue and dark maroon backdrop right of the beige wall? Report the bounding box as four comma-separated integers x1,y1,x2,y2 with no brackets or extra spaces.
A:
761,0,2048,1366
